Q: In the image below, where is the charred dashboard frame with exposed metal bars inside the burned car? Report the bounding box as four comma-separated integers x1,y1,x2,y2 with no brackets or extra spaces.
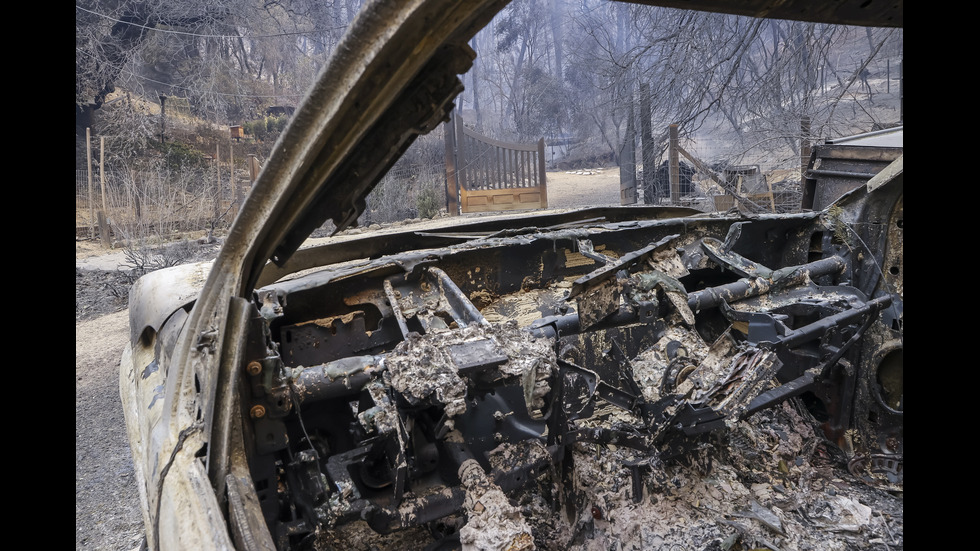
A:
242,194,903,545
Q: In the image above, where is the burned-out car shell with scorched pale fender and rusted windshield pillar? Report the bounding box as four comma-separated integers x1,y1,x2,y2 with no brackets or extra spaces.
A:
120,0,904,549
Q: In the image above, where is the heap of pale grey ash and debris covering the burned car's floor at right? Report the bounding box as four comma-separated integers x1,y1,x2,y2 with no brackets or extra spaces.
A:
524,402,904,551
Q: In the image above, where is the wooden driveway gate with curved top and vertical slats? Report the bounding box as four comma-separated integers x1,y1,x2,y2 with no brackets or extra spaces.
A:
445,112,548,215
